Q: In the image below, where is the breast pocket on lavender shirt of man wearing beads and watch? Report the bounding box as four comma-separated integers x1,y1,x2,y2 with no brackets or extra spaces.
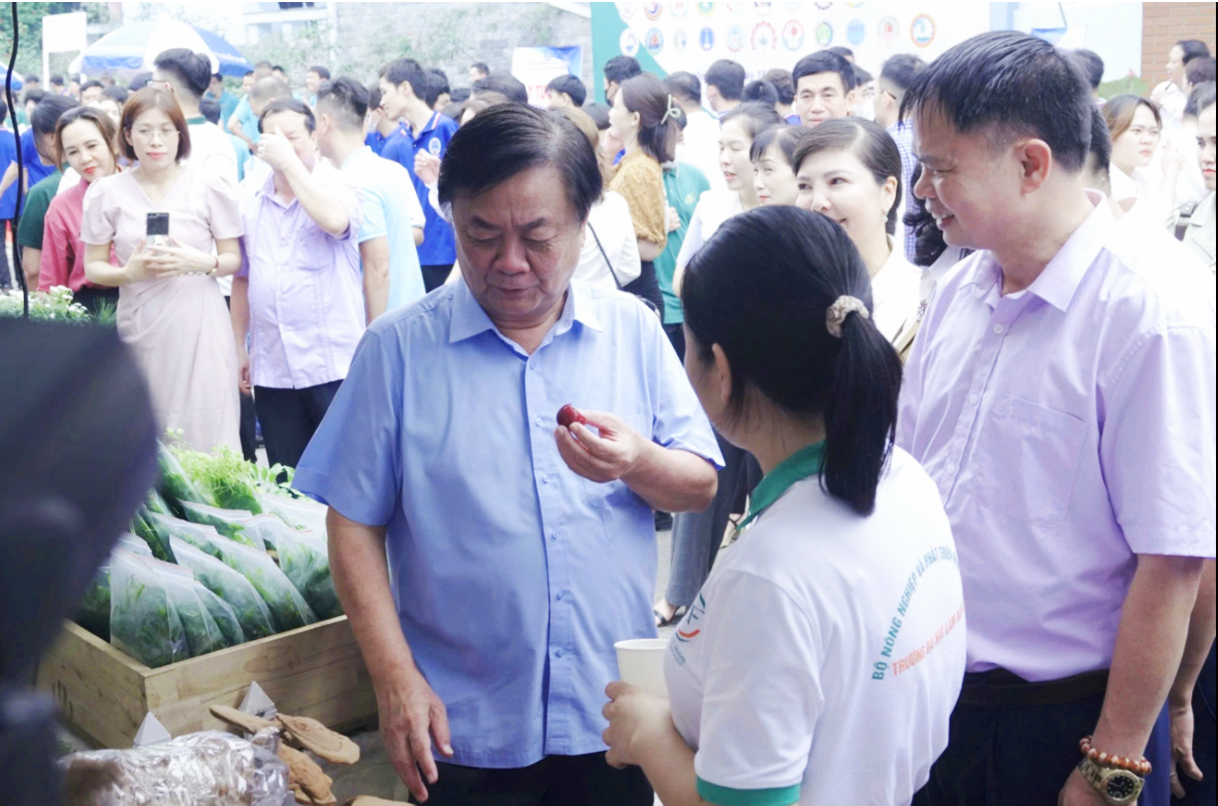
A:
973,394,1086,527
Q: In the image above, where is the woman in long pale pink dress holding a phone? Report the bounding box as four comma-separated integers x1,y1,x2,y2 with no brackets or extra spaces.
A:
80,88,242,453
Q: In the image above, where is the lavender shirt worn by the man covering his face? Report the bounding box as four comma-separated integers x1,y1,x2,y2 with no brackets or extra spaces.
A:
238,161,365,388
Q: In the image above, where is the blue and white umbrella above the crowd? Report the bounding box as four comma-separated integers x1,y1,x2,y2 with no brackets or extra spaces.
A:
68,19,253,78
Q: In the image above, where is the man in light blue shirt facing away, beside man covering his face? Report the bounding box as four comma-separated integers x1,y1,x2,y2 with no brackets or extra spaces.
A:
314,77,426,323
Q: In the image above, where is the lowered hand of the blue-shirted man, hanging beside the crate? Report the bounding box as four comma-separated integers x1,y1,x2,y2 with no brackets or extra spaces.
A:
376,670,453,804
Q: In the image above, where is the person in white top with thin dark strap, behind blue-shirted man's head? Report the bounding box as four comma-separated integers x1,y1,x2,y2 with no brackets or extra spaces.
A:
551,107,642,289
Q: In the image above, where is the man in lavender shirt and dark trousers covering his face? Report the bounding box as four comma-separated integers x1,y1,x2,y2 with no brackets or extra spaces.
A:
233,99,365,468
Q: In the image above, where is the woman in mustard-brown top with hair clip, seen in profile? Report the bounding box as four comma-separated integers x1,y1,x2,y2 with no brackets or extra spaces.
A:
609,73,681,310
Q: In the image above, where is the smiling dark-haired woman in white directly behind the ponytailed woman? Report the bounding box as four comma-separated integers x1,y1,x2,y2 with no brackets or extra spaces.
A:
794,118,922,341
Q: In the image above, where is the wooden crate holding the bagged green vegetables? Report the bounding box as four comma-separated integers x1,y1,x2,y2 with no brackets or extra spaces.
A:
38,616,376,748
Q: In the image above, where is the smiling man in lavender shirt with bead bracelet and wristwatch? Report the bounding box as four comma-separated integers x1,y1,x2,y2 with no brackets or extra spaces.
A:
898,32,1218,806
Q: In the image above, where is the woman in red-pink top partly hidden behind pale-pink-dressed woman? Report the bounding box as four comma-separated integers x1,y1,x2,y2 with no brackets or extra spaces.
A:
38,106,118,313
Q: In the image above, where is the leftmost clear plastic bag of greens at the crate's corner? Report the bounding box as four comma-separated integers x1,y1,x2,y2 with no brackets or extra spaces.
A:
110,549,190,668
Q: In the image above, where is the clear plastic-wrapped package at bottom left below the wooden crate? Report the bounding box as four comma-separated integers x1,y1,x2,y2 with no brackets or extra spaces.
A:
61,728,290,806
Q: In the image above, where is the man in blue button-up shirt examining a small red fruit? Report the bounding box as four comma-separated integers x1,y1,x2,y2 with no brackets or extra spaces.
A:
295,103,722,806
